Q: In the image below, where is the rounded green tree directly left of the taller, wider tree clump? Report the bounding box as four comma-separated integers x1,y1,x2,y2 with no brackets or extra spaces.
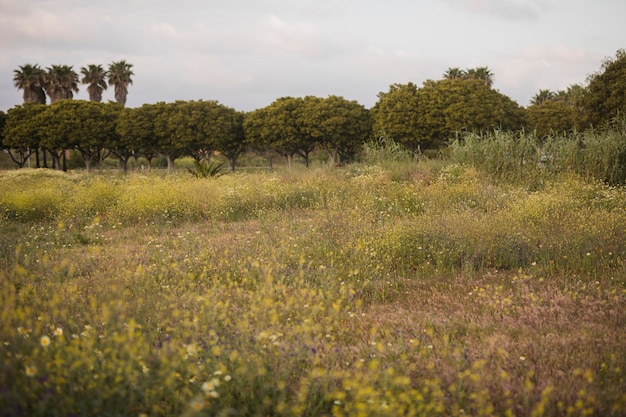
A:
302,96,372,166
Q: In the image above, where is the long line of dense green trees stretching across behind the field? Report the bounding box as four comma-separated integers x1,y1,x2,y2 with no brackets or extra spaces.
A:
0,50,626,170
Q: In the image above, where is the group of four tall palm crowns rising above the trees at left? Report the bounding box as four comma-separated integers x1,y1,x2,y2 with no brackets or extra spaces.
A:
13,60,134,105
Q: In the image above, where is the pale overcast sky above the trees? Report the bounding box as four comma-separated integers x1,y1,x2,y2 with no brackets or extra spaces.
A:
0,0,626,111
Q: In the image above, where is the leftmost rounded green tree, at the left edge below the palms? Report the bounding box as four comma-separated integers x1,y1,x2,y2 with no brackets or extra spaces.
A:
2,103,47,168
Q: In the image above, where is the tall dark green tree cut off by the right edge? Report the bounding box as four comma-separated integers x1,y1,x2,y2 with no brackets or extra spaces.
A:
582,49,626,126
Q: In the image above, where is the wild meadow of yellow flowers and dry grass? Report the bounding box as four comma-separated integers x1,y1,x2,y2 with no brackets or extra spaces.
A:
0,161,626,416
